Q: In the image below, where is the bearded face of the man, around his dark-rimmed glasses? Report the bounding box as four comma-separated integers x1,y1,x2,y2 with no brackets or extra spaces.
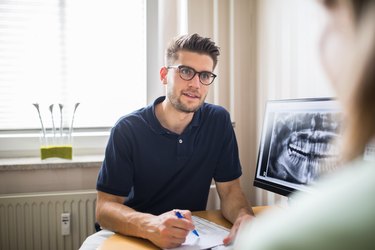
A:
164,51,213,113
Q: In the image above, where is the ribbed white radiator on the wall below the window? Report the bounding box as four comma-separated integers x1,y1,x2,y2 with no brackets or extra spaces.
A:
0,190,96,250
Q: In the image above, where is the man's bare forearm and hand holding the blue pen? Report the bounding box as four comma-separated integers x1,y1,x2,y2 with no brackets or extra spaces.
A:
96,191,194,248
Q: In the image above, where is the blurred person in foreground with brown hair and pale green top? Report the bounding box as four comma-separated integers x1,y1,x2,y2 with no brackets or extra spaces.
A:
234,0,375,250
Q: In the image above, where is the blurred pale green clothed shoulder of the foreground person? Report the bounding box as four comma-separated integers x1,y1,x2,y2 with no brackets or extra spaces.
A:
235,159,375,249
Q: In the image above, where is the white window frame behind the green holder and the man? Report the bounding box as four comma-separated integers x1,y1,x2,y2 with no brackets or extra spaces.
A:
0,1,164,158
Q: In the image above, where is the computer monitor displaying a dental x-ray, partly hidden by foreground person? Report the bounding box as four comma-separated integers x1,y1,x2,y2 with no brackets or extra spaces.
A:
254,99,342,195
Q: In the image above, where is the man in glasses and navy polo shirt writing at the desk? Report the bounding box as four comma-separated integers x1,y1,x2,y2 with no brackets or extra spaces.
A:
96,34,253,248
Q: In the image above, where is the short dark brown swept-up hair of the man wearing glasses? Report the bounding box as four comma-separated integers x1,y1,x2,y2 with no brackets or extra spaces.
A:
165,34,220,69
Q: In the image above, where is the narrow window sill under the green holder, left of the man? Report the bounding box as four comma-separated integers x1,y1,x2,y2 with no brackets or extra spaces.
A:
0,154,104,172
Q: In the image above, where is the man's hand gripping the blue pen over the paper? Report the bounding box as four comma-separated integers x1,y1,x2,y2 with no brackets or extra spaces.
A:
146,210,194,248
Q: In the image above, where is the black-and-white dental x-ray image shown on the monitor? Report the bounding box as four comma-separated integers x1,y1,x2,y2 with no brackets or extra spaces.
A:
265,112,341,184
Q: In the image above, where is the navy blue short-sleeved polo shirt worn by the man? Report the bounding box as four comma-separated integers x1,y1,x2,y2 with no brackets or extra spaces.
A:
96,97,241,215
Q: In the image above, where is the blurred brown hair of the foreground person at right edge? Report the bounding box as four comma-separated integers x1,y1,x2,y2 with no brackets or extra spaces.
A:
324,0,375,161
